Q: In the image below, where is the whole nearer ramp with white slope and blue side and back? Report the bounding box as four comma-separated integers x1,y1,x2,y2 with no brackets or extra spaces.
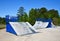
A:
6,16,36,35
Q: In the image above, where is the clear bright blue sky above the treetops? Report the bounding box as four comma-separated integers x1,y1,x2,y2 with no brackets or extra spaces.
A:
0,0,60,17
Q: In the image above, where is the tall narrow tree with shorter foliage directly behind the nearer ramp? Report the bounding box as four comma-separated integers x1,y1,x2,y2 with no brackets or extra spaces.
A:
17,7,28,22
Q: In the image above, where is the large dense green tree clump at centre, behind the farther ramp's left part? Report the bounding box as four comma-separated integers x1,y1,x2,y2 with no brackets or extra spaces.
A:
29,7,47,25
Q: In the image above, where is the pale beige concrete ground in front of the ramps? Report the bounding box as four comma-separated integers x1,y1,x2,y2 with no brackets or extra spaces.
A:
0,28,60,41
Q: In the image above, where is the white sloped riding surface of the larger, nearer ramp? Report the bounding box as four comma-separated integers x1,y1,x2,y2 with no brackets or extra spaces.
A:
9,22,36,35
